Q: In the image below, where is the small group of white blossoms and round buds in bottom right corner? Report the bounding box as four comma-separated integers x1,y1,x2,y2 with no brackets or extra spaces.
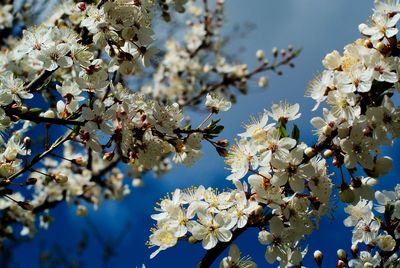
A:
339,184,400,268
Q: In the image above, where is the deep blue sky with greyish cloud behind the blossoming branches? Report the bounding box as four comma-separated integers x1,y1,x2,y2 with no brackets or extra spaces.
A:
15,0,399,267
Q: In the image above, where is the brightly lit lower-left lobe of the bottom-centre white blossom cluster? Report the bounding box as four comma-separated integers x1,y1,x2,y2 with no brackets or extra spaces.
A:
149,186,258,258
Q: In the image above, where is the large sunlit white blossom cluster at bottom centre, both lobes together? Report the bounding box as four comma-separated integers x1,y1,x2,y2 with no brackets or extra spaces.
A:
150,103,332,265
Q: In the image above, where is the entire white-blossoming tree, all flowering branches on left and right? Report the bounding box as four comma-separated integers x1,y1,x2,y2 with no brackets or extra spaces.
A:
0,0,400,267
